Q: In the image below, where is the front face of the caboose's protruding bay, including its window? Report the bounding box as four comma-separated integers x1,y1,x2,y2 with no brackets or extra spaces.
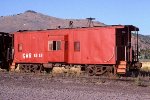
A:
48,35,65,62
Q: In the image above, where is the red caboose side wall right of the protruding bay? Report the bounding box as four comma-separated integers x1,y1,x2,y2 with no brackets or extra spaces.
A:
70,28,116,64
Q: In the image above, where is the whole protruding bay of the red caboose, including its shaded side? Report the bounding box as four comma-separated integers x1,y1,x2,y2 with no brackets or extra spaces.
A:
45,29,68,63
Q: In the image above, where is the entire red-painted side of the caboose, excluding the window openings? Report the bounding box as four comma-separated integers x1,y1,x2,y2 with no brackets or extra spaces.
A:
14,26,137,64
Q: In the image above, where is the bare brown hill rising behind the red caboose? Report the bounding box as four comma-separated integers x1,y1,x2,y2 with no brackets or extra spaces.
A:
0,10,150,50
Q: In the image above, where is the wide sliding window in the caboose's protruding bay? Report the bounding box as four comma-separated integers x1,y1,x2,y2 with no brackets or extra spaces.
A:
48,41,61,51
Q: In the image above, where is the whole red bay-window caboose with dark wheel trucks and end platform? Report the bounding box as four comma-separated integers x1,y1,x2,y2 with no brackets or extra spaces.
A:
14,25,139,75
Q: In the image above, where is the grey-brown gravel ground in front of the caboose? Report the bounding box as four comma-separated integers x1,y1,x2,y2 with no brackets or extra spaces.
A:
0,72,150,100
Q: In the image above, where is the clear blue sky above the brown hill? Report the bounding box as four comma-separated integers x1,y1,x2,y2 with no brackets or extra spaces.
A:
0,0,150,35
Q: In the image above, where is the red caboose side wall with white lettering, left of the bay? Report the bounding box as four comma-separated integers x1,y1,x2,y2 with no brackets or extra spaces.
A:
14,31,47,63
